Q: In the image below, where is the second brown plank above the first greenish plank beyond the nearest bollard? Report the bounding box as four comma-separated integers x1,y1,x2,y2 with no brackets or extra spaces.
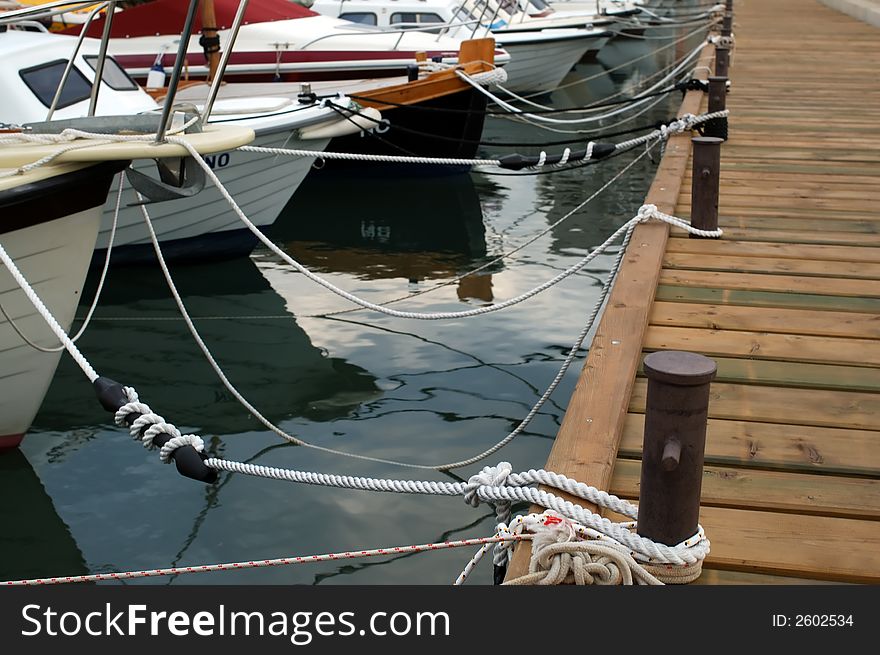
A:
663,252,880,280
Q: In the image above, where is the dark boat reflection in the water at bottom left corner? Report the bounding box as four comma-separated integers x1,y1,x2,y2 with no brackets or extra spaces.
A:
0,449,88,580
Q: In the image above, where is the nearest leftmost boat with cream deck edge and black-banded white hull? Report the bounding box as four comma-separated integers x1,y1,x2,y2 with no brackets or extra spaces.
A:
0,0,254,449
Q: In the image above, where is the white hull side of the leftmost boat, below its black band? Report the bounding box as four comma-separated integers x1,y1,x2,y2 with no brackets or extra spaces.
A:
0,206,102,448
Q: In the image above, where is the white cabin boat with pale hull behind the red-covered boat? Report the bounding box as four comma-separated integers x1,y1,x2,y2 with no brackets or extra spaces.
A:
312,0,613,93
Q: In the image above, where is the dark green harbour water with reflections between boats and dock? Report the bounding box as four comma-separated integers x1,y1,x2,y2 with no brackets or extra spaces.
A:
0,28,689,584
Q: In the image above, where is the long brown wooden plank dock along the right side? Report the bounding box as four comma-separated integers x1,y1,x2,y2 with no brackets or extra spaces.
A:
508,0,880,584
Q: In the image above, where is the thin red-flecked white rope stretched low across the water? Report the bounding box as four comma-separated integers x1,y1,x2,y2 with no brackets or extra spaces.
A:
0,534,531,587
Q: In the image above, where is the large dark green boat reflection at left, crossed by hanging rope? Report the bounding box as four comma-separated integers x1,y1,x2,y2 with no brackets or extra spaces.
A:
36,258,378,436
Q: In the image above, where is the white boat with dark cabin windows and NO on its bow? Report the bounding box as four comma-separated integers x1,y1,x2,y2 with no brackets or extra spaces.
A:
0,29,381,263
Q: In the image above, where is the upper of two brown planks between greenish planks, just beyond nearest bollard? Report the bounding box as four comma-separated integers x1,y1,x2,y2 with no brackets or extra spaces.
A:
651,302,880,339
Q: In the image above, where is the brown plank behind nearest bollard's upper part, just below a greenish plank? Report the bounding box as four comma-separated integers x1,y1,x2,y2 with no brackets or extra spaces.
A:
629,379,880,430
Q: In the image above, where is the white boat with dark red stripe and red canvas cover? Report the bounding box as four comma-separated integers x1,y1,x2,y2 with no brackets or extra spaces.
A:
62,0,510,82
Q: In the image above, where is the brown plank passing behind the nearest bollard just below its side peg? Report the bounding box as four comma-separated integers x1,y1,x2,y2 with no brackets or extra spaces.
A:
610,459,880,520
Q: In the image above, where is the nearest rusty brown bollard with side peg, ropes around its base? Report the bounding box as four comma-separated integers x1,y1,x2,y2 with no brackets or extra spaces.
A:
638,350,716,546
